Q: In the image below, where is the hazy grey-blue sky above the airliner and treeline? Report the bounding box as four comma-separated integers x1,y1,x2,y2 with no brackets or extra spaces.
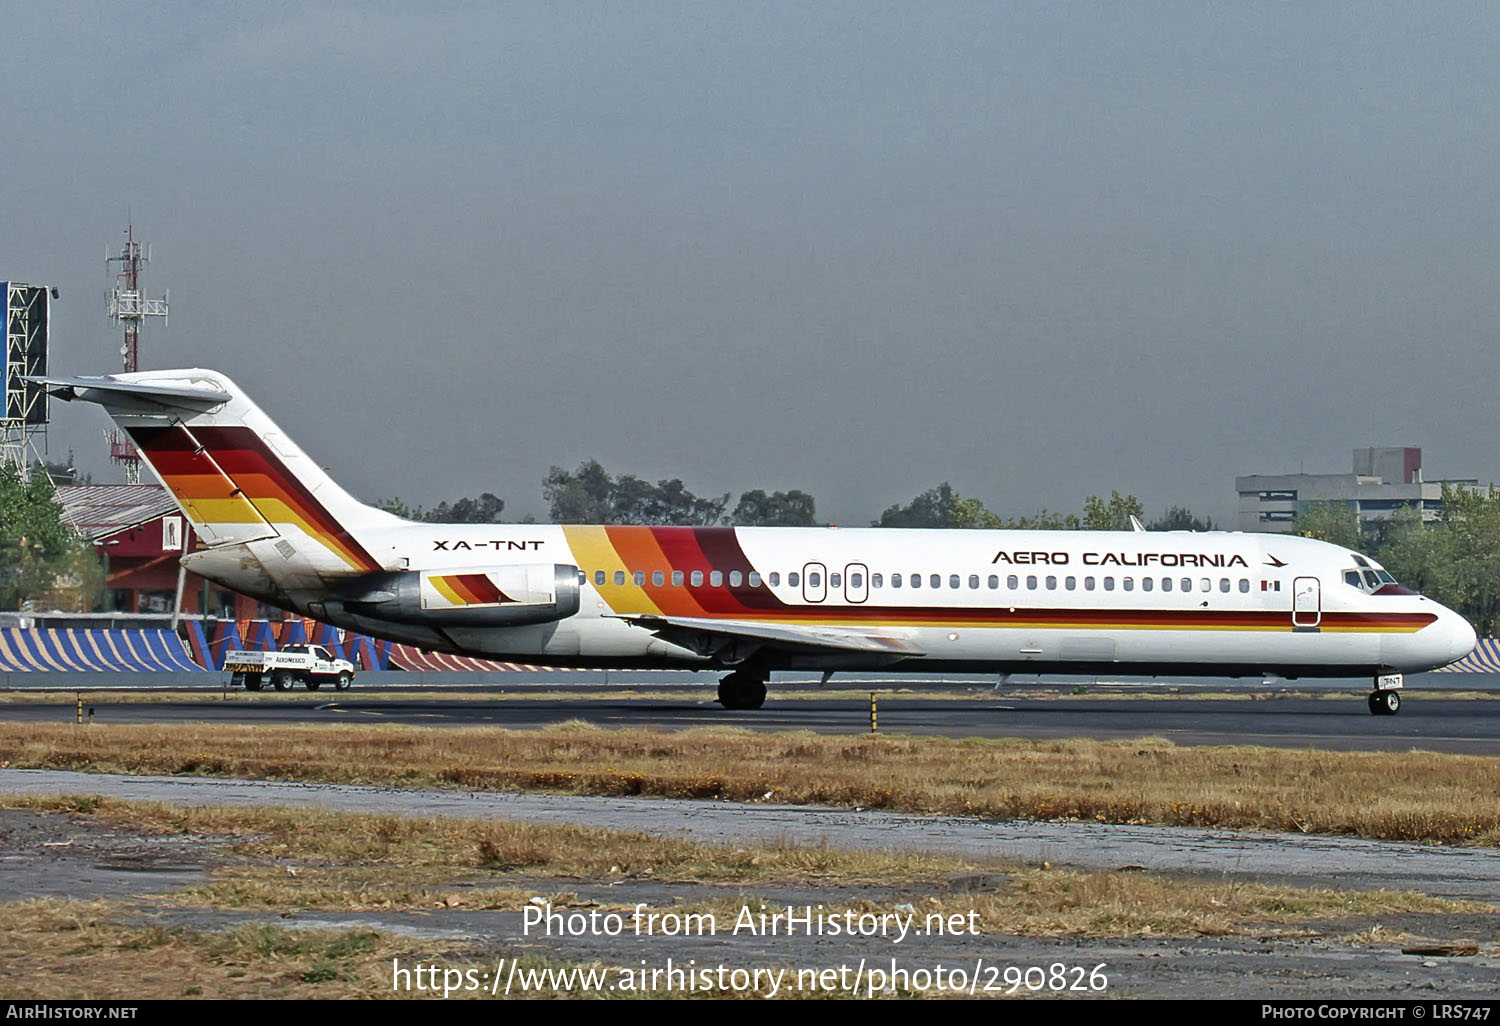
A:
0,0,1500,527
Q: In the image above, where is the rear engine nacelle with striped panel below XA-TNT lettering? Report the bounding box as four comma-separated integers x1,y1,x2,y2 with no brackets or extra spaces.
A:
328,563,582,627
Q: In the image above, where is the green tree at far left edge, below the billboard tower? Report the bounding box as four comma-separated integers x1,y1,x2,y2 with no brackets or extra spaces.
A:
0,464,102,609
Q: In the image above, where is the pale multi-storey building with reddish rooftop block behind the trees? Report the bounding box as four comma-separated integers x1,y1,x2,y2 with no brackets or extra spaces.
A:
1235,446,1490,534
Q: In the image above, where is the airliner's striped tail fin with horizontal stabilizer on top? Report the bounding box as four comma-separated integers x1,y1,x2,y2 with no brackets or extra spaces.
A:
39,369,401,578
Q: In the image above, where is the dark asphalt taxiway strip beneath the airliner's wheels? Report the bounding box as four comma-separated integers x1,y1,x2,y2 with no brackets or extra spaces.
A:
0,690,1500,755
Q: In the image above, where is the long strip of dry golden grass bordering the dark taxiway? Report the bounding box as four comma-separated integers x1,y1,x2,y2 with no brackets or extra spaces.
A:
0,723,1500,846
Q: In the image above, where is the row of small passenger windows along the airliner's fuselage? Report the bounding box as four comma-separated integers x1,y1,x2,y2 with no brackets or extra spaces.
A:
594,570,1250,594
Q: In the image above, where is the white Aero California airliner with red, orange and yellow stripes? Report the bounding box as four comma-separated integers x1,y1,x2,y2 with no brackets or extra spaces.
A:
38,371,1475,716
